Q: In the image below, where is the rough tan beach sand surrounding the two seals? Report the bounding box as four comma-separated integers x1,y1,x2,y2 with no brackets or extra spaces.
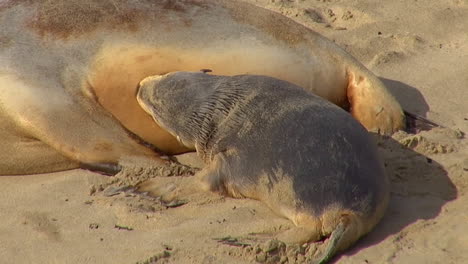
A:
0,0,468,264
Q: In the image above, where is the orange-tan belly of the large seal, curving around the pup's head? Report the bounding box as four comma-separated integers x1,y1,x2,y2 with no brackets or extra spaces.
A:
88,44,343,154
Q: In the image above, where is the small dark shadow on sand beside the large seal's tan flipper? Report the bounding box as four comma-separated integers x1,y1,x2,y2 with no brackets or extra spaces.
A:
379,77,430,117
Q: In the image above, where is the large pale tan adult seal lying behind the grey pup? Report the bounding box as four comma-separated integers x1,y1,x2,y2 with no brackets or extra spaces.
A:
0,0,404,175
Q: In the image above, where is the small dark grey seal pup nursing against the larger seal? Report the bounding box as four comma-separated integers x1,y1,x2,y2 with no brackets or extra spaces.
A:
137,72,389,263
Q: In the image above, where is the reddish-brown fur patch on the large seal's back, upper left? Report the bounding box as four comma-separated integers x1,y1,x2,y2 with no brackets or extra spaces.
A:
18,0,206,39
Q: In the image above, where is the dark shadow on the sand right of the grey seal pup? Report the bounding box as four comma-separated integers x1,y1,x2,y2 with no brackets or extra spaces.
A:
344,135,457,256
